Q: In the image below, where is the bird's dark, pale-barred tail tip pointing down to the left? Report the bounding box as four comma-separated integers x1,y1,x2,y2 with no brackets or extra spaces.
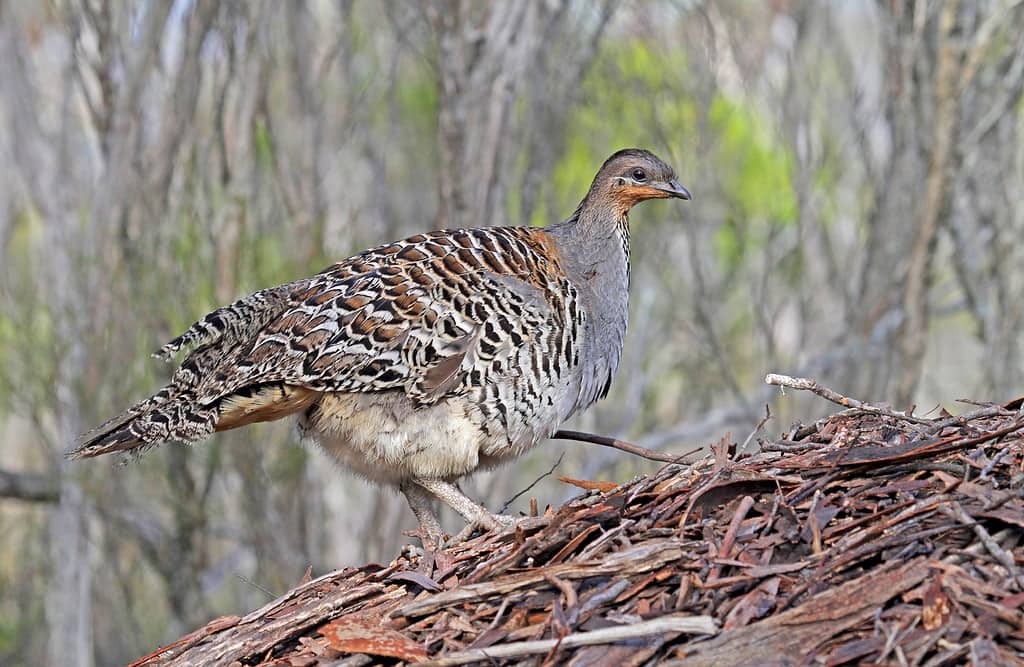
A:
65,385,217,460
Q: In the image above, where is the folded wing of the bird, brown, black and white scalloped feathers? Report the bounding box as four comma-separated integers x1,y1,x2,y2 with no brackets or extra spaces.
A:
165,227,566,418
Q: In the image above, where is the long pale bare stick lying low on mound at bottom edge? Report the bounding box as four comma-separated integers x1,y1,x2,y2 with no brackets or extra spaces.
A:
419,616,718,667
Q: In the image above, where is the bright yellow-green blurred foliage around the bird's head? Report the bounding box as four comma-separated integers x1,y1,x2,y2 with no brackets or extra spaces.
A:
530,38,798,261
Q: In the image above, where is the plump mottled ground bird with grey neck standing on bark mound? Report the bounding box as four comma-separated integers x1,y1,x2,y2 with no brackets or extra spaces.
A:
67,149,690,549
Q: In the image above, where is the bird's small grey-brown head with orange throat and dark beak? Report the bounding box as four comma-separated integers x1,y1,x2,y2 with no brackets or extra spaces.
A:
591,149,690,214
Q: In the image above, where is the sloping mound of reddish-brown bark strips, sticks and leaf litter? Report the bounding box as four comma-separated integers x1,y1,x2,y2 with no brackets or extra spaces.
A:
135,402,1024,667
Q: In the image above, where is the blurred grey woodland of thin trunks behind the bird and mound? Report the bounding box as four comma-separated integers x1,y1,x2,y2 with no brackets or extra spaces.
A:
0,0,1024,665
